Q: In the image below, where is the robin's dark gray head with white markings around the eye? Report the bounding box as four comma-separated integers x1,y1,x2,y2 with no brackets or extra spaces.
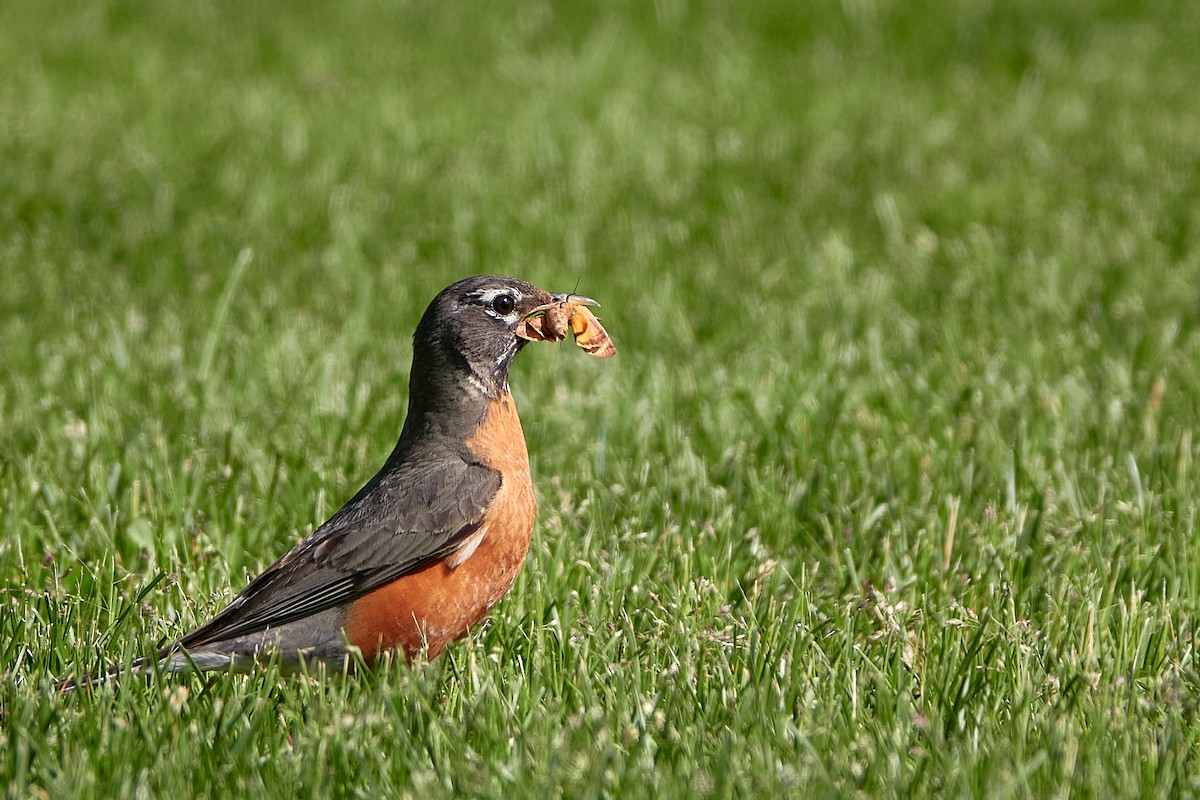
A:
409,275,556,410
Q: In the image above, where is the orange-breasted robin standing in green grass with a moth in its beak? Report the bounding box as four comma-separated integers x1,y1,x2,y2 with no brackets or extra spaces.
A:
64,276,613,688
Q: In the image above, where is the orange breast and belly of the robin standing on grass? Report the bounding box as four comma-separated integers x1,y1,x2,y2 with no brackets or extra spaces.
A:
346,392,538,662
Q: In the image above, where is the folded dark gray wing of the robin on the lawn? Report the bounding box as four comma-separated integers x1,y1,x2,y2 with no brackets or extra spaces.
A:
178,458,500,648
